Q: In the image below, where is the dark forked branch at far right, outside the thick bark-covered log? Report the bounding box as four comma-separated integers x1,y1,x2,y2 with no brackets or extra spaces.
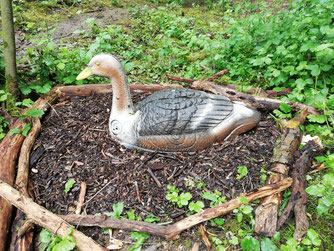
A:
277,141,323,242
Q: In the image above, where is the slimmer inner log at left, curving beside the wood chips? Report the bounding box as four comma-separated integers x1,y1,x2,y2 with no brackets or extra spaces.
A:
10,118,41,251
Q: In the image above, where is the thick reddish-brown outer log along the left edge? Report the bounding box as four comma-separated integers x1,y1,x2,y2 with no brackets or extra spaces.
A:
0,88,57,250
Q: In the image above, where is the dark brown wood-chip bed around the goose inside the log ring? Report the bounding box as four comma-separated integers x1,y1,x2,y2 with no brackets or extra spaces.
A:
30,89,279,246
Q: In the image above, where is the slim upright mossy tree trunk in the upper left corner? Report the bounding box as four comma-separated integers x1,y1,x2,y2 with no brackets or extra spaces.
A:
1,0,19,106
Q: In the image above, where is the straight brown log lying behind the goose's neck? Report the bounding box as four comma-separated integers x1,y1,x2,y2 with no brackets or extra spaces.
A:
57,84,182,97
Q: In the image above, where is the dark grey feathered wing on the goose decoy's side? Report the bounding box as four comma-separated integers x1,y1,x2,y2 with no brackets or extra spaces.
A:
136,89,233,136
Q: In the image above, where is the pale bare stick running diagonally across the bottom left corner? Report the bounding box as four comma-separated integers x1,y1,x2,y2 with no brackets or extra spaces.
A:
0,180,105,251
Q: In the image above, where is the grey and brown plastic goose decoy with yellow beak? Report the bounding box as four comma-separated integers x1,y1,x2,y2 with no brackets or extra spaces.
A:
76,53,260,152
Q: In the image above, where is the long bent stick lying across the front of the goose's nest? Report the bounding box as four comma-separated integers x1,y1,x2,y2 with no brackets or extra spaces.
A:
60,178,292,239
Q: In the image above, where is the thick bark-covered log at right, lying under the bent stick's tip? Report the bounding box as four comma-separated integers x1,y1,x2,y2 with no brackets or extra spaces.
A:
254,110,307,237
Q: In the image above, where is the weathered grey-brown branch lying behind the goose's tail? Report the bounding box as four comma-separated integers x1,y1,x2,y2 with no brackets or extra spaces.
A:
191,81,320,115
